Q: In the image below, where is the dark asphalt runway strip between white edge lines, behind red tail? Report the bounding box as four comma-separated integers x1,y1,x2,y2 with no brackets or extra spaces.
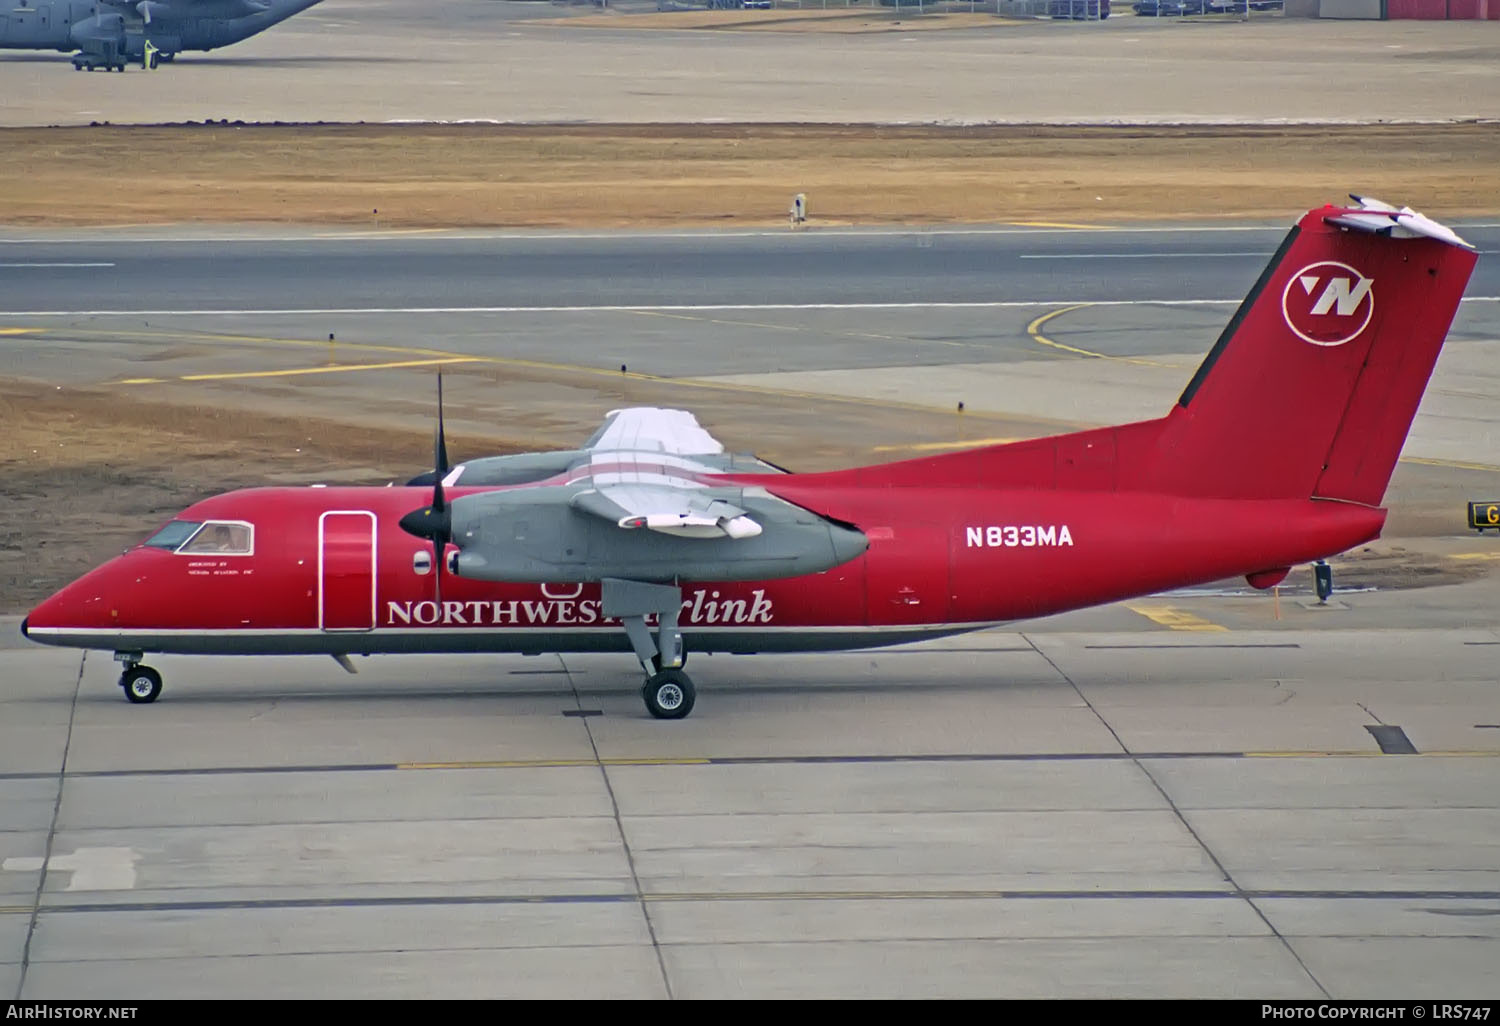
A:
0,225,1500,317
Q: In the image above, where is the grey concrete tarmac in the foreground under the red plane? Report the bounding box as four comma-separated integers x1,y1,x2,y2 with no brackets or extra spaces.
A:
0,612,1500,1001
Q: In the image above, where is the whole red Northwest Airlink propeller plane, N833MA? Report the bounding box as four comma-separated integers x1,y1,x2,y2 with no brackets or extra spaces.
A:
21,197,1478,719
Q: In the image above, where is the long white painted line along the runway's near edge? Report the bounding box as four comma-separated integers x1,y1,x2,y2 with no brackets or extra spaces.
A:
0,296,1500,318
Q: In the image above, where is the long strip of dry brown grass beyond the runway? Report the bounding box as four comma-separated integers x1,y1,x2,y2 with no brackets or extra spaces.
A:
0,123,1500,228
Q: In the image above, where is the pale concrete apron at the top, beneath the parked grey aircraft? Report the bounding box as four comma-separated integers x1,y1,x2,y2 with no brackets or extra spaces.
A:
0,0,1500,126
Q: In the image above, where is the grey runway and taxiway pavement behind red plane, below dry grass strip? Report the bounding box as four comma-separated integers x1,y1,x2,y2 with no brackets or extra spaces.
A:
0,224,1500,470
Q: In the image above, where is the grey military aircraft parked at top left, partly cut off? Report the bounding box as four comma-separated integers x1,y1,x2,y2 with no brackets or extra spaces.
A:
0,0,320,71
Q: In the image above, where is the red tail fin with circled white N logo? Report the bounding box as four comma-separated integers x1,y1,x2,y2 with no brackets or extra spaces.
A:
1140,197,1476,506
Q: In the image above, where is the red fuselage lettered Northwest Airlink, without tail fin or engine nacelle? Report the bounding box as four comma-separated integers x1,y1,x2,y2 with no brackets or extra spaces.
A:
24,476,1385,654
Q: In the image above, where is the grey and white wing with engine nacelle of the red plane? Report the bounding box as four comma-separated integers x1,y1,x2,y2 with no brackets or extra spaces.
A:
417,407,869,584
